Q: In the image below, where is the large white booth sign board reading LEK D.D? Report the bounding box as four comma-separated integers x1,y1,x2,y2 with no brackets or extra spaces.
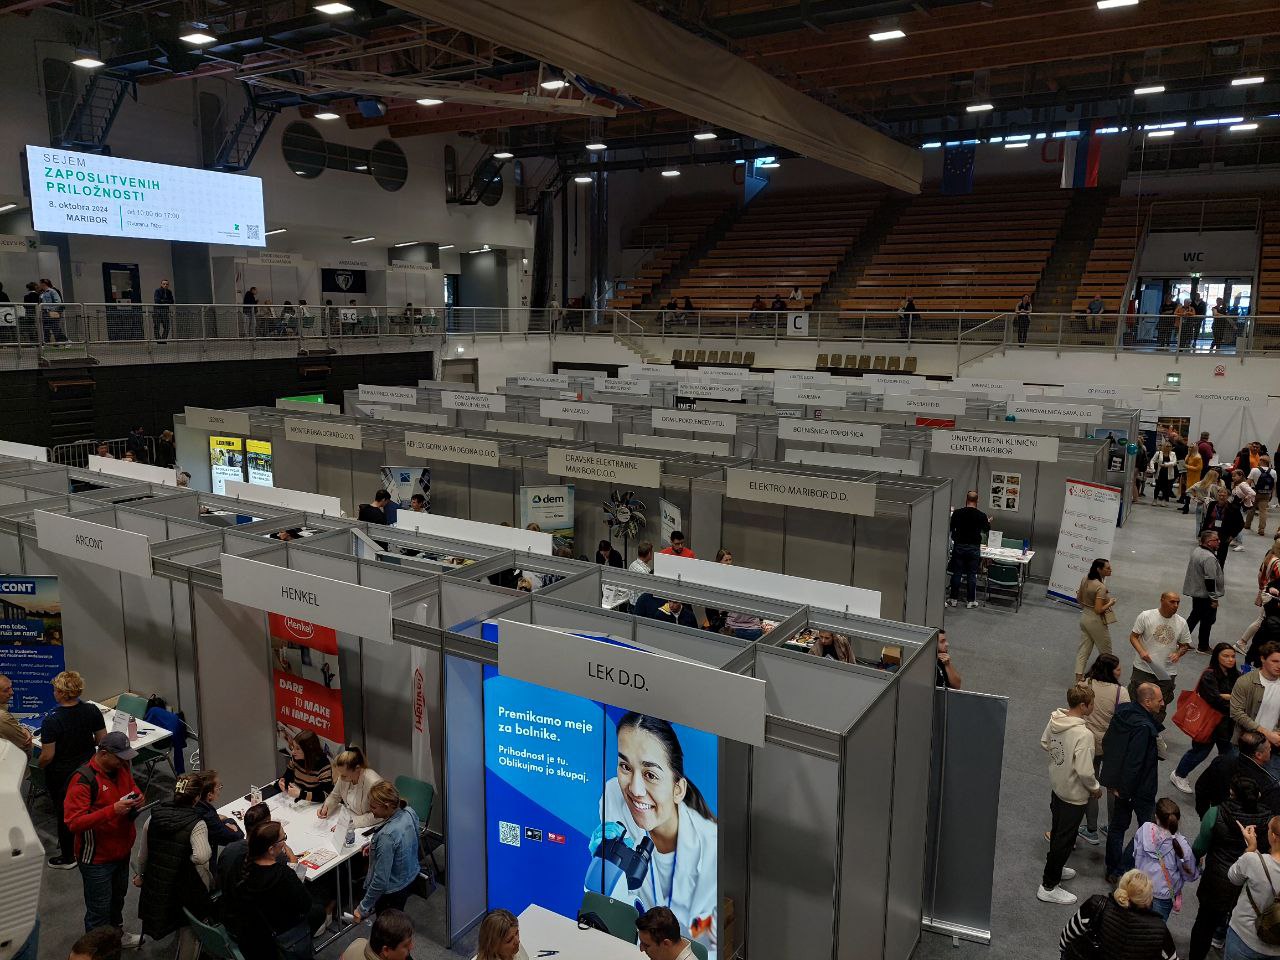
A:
498,621,767,746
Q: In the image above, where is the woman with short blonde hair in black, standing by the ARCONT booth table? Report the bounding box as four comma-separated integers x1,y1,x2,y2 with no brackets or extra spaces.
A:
38,669,106,870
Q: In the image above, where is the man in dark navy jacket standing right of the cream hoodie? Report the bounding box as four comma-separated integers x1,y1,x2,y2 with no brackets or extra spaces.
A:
1098,680,1176,883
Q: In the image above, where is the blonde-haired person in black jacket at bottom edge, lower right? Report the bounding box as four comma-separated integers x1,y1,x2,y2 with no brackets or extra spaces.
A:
1057,869,1178,960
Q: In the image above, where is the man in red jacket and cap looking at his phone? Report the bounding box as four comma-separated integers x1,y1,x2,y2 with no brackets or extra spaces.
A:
63,731,142,947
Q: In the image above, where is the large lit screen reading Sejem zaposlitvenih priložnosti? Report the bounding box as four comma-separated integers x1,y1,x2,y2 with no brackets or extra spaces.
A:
27,145,266,247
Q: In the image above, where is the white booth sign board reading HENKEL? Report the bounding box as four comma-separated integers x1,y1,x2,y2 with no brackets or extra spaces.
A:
220,553,392,644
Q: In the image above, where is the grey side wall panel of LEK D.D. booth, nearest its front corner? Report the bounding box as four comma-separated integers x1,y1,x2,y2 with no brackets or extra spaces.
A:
824,694,896,960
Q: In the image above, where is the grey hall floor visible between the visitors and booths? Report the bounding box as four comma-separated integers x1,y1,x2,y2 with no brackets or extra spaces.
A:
30,491,1270,960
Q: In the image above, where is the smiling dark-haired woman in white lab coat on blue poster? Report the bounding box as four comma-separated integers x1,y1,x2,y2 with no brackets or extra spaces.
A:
602,713,719,960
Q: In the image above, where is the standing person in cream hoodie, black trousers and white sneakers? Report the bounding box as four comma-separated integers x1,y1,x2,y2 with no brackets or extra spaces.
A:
1036,685,1102,904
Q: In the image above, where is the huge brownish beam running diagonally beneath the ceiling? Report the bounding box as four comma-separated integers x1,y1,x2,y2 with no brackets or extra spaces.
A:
393,0,923,193
